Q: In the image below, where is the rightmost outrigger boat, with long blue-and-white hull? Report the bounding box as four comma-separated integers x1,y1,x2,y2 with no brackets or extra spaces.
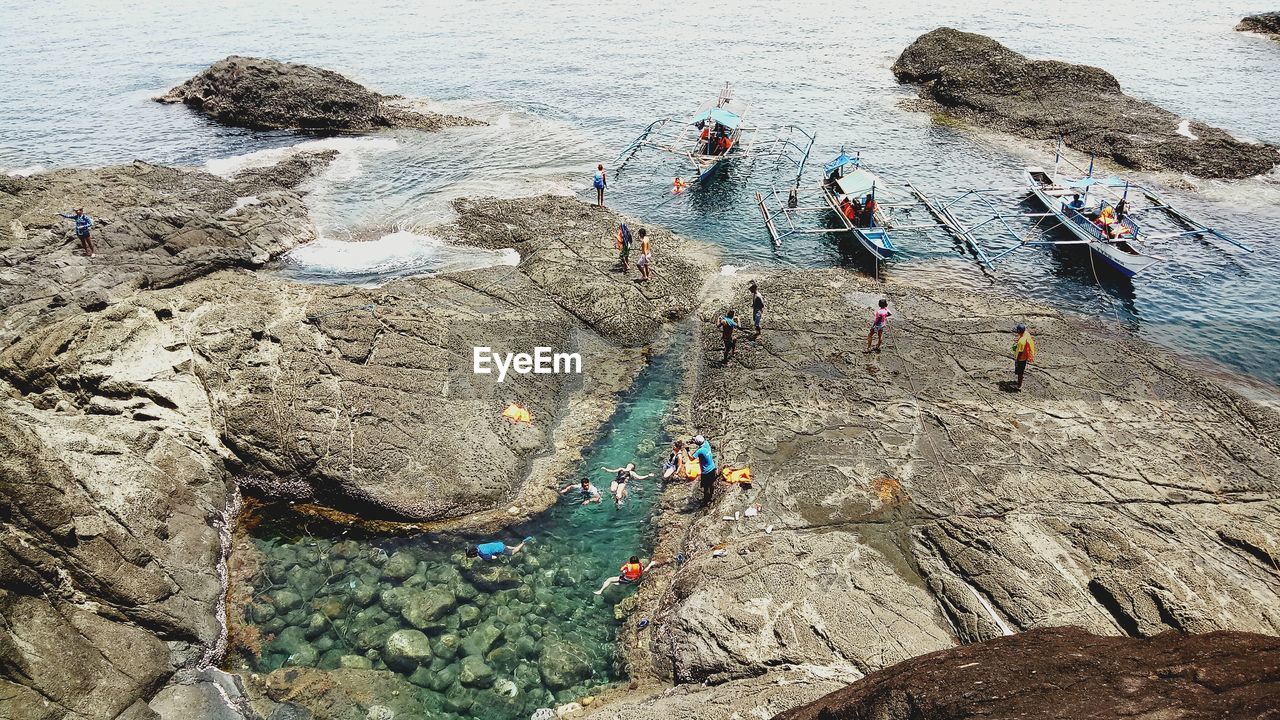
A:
937,149,1253,278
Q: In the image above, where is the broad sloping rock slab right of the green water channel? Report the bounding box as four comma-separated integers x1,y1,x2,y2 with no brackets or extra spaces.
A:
583,270,1280,720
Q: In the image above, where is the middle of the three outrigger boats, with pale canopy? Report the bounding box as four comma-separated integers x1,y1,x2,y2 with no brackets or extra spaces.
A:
755,149,950,260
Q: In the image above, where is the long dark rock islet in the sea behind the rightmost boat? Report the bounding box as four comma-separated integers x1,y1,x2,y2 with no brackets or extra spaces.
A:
893,27,1280,178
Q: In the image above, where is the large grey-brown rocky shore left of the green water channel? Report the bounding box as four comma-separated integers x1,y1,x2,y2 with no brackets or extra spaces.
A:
0,149,714,719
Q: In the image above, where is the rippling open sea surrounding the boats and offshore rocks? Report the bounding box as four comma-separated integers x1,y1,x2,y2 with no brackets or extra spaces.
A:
0,0,1280,383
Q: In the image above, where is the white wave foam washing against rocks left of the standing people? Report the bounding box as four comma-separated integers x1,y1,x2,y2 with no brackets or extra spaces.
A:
287,231,520,281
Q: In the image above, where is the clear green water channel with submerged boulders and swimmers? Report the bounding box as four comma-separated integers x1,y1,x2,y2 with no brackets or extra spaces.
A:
228,343,681,719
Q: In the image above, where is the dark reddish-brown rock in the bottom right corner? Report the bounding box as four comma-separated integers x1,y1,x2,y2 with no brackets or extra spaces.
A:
777,628,1280,720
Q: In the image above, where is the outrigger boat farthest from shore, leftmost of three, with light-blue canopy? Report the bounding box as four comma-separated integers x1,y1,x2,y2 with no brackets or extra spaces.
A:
613,83,814,186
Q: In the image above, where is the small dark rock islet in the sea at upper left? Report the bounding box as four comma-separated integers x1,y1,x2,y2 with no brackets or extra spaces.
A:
156,55,483,132
